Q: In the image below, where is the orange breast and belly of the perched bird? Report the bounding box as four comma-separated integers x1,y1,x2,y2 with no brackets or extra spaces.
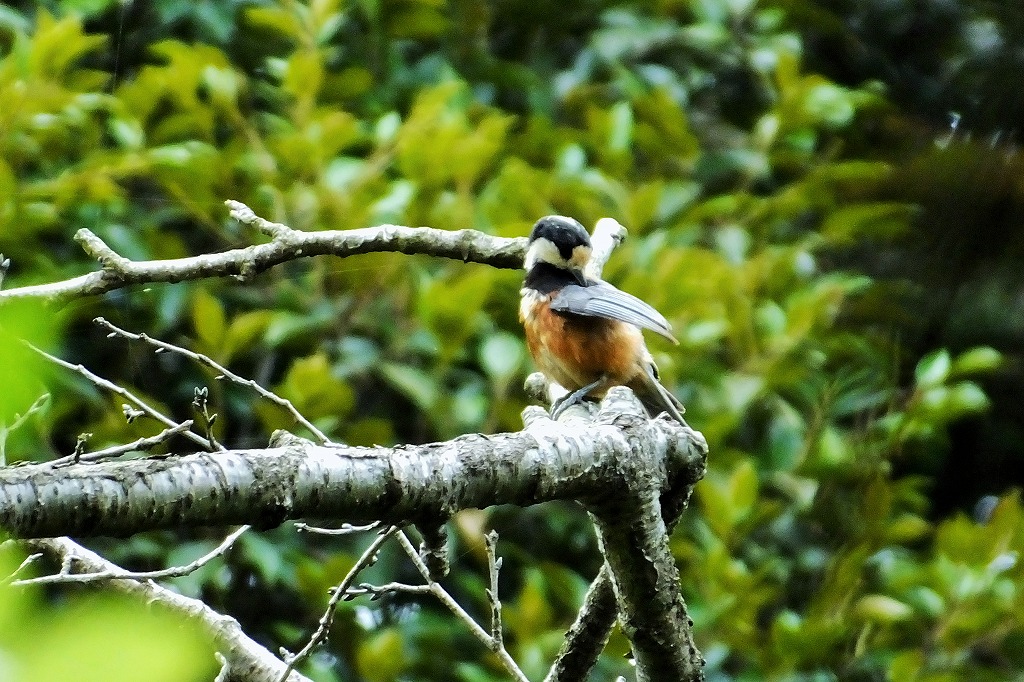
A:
523,302,644,397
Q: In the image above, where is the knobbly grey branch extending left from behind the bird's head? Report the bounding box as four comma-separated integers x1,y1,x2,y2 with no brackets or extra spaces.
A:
0,201,526,305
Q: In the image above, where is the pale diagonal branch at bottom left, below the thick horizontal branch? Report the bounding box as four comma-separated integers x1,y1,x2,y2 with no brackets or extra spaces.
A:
26,538,310,682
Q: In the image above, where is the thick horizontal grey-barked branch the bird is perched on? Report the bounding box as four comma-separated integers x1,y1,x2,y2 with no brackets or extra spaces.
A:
0,391,703,538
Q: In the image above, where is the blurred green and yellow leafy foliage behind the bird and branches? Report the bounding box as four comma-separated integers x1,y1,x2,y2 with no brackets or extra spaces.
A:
0,0,1024,682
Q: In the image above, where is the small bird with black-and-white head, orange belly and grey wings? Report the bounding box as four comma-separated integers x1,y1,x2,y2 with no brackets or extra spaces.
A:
519,215,686,424
